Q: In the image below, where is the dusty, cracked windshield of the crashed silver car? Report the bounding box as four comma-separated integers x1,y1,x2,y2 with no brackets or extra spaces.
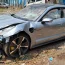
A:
15,5,46,20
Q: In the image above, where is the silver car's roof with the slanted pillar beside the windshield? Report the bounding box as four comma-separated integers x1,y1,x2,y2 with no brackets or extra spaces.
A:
31,3,65,21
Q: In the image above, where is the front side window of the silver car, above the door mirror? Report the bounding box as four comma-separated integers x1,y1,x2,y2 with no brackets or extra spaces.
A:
44,9,61,19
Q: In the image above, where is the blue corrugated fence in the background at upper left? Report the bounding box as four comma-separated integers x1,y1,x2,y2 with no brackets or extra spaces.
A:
0,0,27,6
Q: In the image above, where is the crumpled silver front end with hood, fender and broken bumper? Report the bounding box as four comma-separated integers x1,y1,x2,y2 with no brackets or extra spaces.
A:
0,15,26,48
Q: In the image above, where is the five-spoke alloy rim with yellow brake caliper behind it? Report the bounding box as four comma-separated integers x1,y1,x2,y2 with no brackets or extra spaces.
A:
9,36,29,57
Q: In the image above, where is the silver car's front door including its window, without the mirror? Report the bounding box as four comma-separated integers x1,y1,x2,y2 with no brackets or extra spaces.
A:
36,8,65,44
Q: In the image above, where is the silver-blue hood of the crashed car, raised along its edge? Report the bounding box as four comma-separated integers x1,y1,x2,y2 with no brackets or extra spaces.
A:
0,15,28,29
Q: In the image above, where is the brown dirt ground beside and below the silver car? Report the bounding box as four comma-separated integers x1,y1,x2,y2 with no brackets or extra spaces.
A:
0,40,65,65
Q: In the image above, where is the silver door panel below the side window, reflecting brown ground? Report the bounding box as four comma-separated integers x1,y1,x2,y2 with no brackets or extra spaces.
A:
33,18,65,43
